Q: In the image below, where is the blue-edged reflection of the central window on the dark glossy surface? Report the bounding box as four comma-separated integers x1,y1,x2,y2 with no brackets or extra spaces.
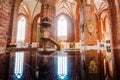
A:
57,56,67,79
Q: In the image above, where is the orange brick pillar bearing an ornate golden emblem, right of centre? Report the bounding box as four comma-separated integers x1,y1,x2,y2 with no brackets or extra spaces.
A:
82,3,97,45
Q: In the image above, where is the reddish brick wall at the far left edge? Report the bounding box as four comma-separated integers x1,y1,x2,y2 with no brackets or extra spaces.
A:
0,0,11,52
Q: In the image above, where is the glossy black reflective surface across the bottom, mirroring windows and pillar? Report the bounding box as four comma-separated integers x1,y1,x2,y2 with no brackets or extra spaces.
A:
0,50,110,80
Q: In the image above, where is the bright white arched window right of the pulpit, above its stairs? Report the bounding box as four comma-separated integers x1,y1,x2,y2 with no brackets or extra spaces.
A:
57,15,68,37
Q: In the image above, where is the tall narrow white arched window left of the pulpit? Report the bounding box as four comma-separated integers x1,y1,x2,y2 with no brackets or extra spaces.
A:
16,17,26,42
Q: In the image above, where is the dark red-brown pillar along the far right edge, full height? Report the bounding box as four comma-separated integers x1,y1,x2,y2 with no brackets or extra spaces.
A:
108,0,120,80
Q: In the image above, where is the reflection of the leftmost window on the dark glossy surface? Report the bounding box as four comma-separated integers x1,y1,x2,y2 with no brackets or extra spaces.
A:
14,52,24,79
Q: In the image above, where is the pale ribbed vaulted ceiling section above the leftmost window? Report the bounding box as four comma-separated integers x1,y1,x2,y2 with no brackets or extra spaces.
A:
19,0,41,19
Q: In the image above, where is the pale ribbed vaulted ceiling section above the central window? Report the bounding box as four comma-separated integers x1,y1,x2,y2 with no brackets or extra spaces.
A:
56,0,77,17
